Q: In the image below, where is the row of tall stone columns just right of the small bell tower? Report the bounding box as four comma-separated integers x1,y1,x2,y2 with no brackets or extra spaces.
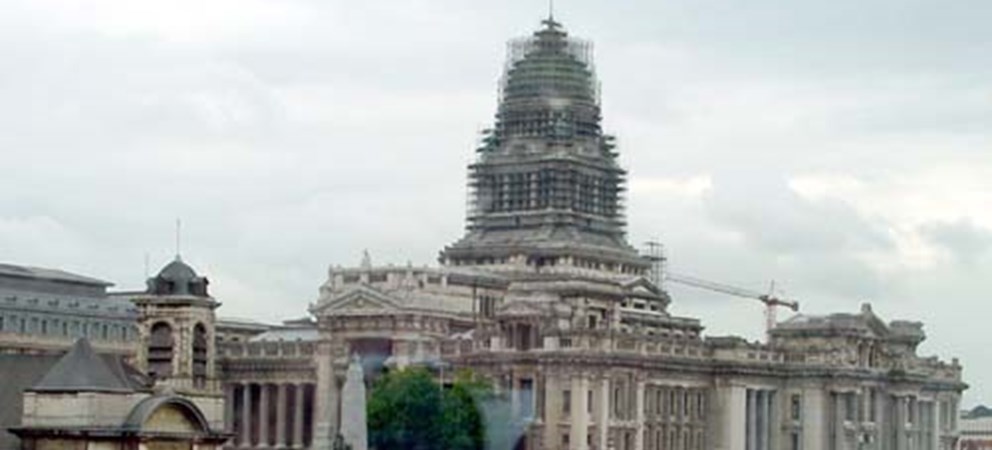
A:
224,382,314,449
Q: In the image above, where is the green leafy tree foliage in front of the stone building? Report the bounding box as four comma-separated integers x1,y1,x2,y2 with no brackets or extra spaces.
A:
368,369,491,450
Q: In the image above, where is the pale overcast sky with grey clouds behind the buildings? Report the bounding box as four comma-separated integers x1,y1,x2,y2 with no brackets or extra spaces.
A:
0,0,992,406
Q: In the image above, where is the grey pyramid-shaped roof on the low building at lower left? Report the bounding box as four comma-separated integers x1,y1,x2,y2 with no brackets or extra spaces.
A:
31,338,134,392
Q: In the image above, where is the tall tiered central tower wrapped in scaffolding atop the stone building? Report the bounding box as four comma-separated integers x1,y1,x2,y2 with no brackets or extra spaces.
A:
440,17,650,275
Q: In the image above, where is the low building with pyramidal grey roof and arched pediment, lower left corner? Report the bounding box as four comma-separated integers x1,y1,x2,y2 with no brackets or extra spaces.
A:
11,338,227,450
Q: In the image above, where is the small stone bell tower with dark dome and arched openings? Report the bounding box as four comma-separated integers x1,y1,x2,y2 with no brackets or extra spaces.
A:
132,255,220,393
